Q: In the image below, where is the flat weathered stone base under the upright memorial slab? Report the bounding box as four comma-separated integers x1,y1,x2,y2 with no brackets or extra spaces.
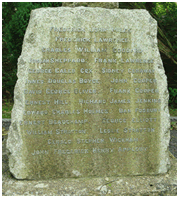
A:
2,150,177,196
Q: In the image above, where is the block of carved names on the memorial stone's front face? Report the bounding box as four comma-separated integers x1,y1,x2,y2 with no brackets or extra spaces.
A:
20,26,161,163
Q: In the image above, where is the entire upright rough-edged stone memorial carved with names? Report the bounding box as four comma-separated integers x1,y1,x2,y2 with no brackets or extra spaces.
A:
7,3,170,179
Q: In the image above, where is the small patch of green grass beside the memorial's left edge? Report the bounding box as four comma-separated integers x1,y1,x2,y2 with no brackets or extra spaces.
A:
2,99,13,118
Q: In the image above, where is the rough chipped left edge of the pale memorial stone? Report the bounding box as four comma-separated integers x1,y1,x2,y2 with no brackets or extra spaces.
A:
6,4,43,179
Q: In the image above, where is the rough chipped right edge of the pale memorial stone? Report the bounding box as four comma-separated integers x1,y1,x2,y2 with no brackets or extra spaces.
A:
149,13,170,173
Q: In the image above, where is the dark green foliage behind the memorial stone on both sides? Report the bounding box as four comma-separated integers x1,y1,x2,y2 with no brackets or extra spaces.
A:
2,2,177,116
